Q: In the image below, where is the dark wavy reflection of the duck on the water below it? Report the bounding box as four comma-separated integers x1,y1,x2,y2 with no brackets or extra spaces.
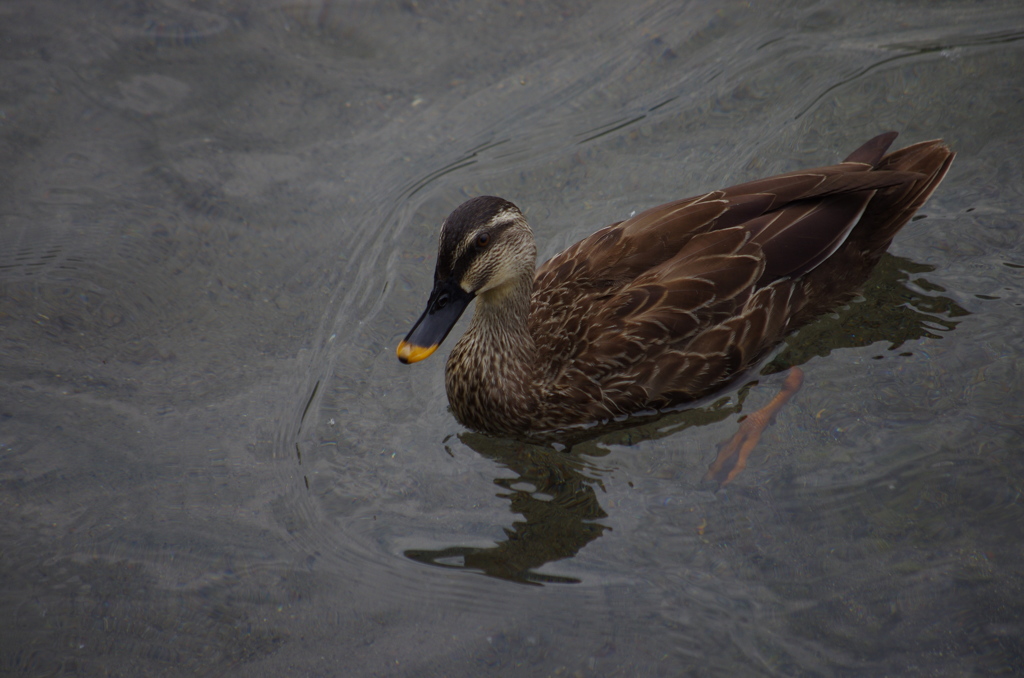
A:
406,254,968,585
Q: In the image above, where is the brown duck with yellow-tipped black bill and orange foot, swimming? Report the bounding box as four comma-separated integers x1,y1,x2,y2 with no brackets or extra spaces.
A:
397,132,953,482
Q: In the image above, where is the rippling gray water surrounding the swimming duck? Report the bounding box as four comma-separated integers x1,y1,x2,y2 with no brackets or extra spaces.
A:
0,0,1024,676
